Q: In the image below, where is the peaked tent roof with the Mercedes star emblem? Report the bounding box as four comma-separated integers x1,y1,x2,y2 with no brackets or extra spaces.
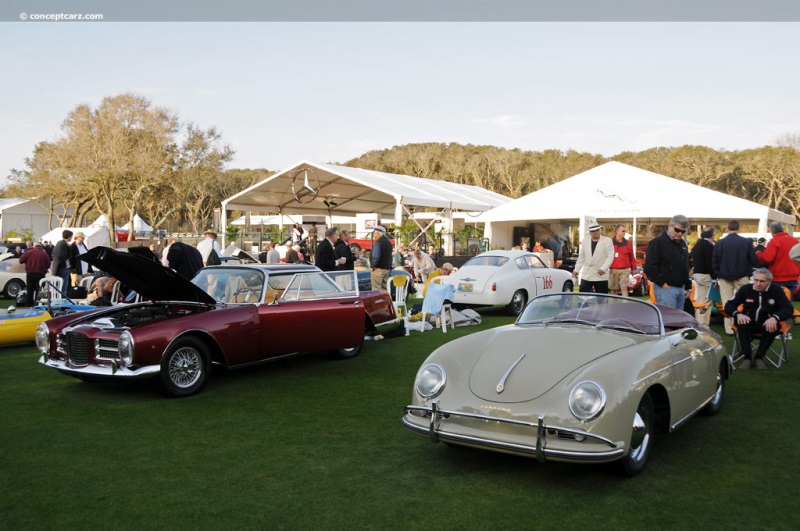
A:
222,161,511,216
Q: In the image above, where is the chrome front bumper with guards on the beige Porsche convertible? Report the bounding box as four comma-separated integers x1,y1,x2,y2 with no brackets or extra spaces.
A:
403,402,625,463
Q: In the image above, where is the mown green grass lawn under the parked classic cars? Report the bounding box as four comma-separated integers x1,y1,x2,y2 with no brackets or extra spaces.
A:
0,298,800,530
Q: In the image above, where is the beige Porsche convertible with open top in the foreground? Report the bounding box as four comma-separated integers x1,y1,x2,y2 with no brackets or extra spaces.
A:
403,293,732,476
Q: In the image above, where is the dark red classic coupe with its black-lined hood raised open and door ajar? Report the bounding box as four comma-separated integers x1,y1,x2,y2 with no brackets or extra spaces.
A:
36,247,400,397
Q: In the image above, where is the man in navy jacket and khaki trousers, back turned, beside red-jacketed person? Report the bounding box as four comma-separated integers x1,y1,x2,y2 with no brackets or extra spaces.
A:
711,219,759,336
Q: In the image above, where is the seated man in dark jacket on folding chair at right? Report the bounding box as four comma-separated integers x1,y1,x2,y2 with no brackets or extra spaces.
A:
725,267,794,369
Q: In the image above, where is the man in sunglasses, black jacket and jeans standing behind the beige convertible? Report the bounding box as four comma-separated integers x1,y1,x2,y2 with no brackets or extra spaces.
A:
644,215,692,310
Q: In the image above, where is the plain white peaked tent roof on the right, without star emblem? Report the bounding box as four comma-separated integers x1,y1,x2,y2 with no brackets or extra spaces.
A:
479,162,795,225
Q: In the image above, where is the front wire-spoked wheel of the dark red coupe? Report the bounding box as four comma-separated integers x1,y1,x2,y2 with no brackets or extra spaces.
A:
158,337,211,398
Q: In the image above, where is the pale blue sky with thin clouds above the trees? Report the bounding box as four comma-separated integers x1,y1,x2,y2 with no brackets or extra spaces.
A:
0,22,800,185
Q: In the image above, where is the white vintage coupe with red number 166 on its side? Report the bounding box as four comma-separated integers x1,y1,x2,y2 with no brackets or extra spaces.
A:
442,251,574,315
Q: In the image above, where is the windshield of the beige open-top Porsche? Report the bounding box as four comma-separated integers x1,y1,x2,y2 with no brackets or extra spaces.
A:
517,293,662,334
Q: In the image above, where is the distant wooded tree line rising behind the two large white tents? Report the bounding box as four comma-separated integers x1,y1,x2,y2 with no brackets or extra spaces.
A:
346,139,800,217
